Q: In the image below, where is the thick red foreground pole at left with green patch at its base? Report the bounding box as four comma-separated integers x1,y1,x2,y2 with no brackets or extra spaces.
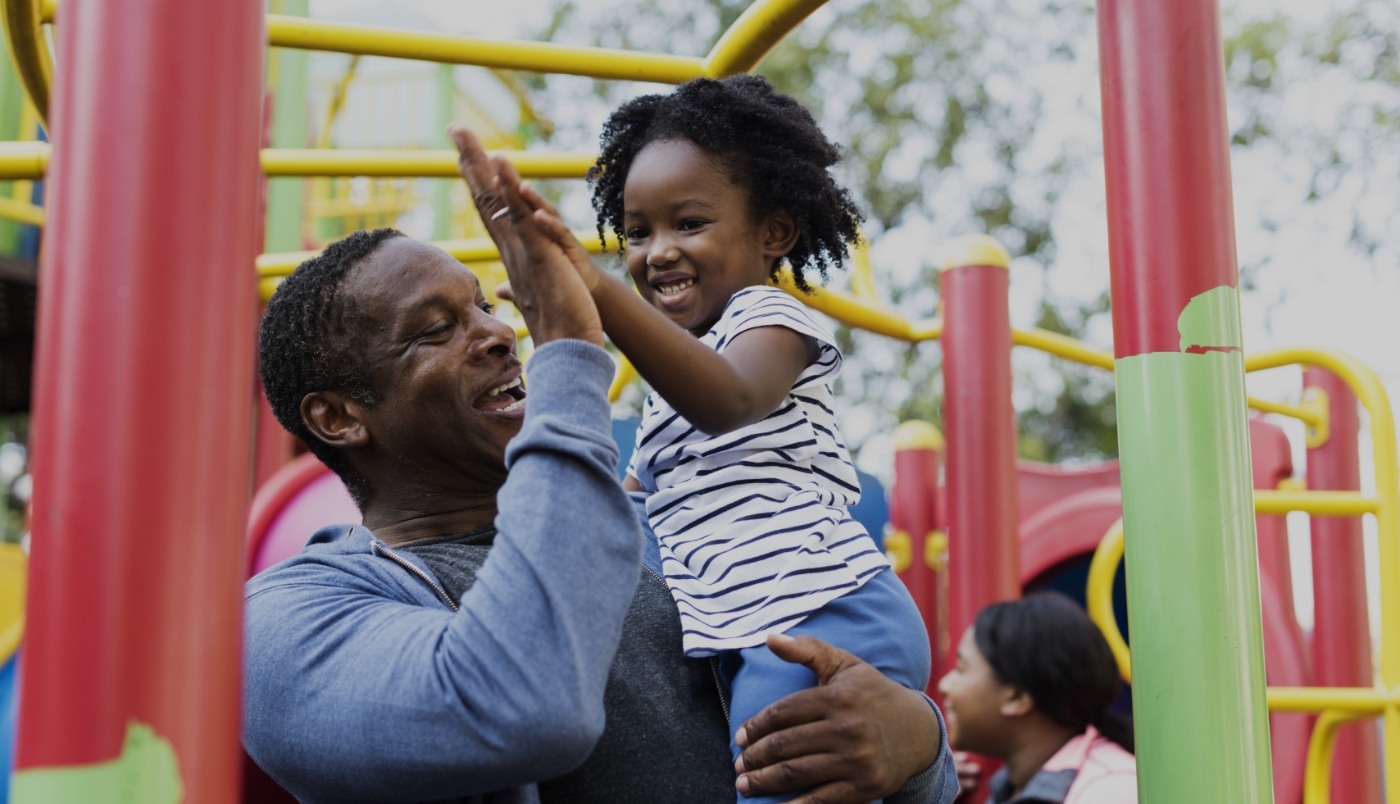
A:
13,0,266,804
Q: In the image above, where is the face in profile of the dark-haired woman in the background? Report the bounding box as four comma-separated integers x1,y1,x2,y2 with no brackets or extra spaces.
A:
938,628,1018,756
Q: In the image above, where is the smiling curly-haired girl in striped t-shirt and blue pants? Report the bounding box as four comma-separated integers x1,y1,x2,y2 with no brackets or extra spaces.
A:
504,76,930,801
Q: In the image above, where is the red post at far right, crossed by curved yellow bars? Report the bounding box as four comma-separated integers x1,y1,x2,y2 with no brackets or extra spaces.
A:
1303,368,1382,804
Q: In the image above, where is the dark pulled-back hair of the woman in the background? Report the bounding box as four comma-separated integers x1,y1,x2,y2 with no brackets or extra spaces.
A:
973,592,1133,751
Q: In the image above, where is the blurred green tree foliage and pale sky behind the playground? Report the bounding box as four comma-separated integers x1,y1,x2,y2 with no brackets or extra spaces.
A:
538,0,1400,476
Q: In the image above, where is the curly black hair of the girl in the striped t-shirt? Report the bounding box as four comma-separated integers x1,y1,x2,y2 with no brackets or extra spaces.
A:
588,74,861,291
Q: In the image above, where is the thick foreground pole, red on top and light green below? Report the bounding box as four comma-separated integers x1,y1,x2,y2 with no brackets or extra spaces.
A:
1099,0,1273,804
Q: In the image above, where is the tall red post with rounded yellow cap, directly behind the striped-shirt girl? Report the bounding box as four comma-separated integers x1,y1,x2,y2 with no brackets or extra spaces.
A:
938,238,1021,677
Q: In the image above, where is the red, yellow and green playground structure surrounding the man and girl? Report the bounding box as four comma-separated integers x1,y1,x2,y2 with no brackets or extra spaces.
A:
0,0,1400,804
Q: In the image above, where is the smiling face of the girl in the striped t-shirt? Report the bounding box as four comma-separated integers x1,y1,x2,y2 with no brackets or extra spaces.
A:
623,140,794,336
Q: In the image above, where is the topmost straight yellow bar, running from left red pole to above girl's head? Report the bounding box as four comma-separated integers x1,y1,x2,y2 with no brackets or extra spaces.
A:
267,14,701,84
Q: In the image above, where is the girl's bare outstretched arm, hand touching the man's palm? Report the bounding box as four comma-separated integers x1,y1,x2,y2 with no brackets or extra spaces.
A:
521,186,818,436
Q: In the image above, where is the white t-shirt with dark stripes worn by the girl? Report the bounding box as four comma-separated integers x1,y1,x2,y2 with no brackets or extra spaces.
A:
627,287,889,657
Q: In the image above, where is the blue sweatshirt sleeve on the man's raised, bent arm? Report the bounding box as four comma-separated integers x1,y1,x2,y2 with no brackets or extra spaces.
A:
245,340,641,801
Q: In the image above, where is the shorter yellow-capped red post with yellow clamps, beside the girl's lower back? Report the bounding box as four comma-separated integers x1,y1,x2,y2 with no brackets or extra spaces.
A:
885,422,952,686
